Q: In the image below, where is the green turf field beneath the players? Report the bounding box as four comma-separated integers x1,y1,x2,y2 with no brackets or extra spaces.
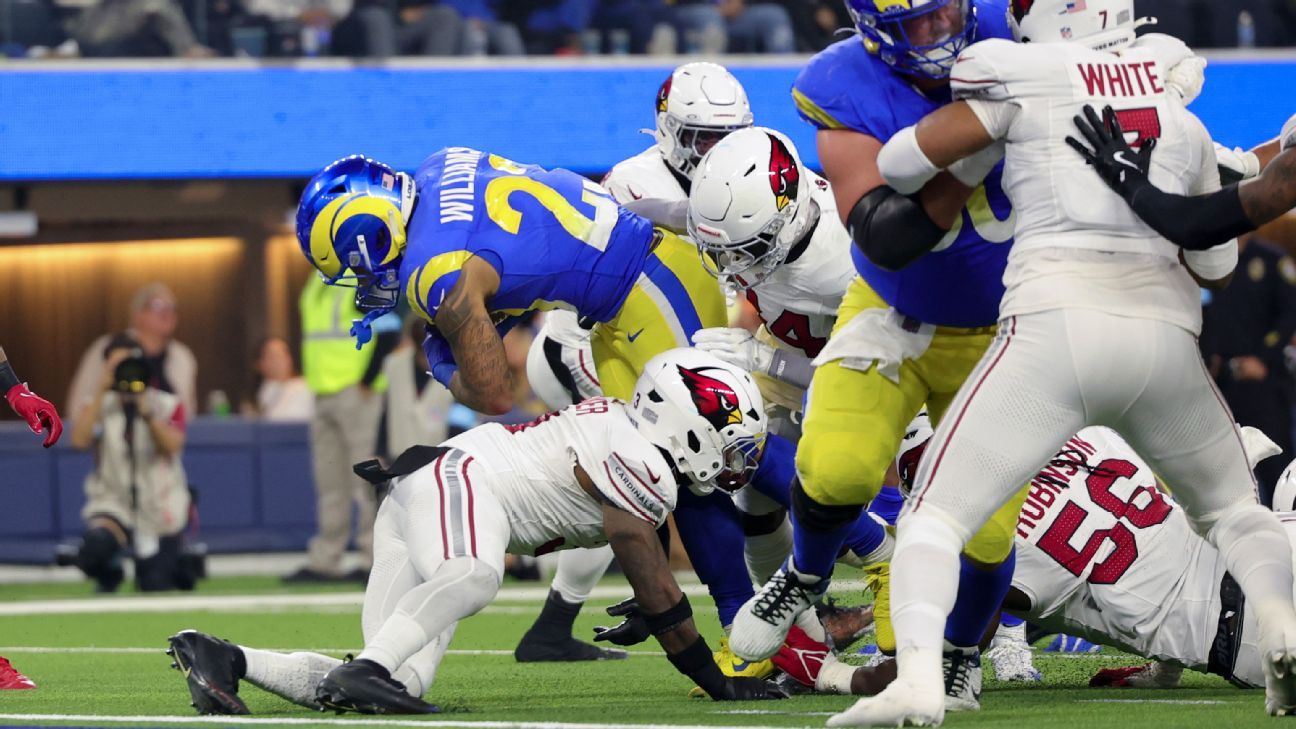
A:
0,579,1274,729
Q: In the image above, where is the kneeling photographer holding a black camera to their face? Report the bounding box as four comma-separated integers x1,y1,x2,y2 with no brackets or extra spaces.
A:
71,335,193,593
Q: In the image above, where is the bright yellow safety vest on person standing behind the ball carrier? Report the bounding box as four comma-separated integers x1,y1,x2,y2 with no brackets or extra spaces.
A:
298,274,386,394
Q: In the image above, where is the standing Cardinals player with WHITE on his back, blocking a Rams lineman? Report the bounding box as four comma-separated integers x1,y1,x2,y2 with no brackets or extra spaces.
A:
850,0,1296,725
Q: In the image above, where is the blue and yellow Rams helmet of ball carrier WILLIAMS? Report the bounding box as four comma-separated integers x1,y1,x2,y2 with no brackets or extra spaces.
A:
297,154,415,311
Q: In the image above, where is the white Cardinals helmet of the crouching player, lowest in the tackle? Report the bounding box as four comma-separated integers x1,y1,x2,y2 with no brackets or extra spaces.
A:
630,348,766,496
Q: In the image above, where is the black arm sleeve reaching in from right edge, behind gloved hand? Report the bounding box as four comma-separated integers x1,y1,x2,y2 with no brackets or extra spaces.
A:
1125,179,1256,250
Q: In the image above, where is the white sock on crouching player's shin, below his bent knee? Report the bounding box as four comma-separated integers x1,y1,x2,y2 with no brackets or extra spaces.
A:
356,556,500,672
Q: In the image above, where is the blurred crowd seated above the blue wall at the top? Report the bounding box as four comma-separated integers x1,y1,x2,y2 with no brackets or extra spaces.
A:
0,0,1296,58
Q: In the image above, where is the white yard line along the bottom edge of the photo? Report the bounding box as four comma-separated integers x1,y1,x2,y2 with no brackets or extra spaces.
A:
0,713,776,729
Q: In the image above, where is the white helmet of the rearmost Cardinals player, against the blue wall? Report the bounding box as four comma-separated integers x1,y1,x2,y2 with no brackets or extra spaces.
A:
654,61,752,178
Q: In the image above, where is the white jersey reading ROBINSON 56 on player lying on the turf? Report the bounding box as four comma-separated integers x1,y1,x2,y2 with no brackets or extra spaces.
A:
1012,427,1223,682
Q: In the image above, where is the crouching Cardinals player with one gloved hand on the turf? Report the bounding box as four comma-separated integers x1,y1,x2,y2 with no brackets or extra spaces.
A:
168,349,785,713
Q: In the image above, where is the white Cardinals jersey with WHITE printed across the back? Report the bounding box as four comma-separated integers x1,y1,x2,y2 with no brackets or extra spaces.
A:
951,40,1236,332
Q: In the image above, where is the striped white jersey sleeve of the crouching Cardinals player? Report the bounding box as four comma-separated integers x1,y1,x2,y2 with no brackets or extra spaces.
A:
590,423,678,527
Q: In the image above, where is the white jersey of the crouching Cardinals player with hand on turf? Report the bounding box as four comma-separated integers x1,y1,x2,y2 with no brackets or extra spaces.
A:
442,397,678,554
